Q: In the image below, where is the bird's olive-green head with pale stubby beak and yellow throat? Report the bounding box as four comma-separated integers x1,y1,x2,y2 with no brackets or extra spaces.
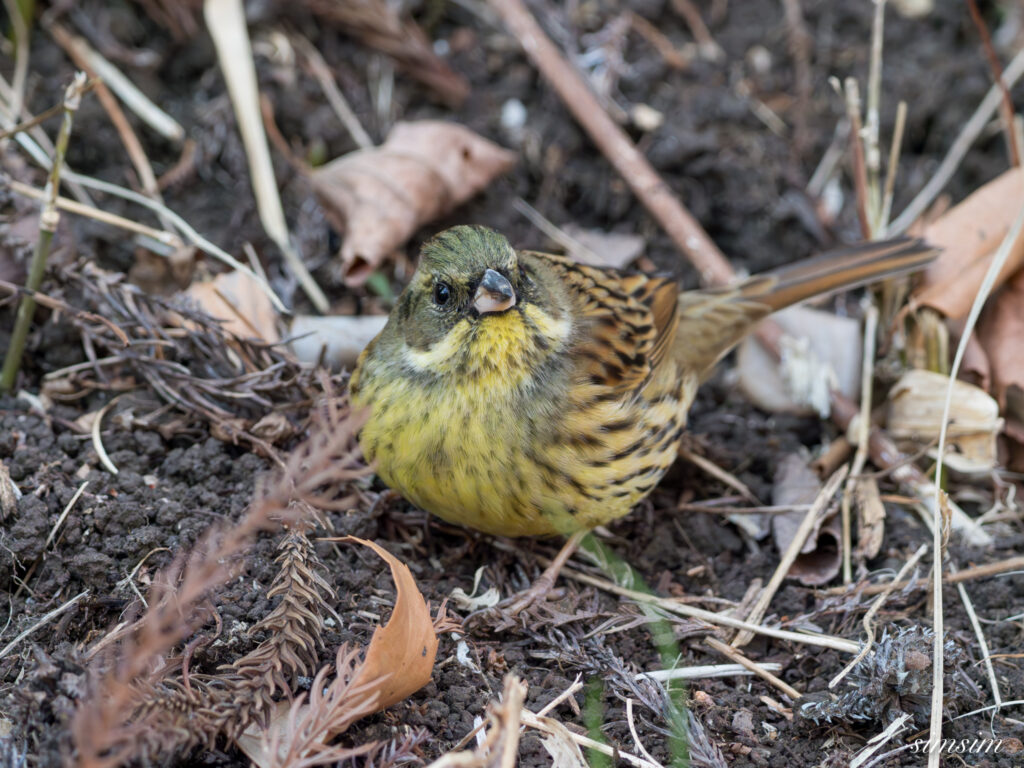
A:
372,226,571,382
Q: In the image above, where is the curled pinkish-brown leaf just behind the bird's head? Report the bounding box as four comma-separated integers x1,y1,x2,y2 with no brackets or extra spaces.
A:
310,120,516,285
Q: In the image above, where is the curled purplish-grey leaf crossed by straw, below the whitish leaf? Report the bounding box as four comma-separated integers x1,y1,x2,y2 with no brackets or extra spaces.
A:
772,454,843,587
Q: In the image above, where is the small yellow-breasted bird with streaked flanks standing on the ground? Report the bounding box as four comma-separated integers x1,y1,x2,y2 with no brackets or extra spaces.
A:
349,225,937,609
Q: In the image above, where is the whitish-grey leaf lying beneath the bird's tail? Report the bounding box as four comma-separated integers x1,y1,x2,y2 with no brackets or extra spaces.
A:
736,306,863,415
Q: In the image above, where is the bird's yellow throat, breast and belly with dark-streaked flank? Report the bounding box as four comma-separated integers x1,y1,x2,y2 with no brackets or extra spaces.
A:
353,307,696,536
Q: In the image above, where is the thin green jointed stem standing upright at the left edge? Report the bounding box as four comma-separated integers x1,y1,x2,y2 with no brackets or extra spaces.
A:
0,72,86,392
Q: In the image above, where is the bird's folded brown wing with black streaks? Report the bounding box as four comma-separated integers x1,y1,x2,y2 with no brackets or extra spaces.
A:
520,252,679,394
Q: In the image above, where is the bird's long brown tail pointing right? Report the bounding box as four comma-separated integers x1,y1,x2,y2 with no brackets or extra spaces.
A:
675,237,938,372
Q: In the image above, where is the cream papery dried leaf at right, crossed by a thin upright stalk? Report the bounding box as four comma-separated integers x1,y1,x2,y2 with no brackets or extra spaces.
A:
887,370,1002,472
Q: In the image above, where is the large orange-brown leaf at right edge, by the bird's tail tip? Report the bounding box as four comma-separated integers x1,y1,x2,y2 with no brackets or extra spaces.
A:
912,168,1024,317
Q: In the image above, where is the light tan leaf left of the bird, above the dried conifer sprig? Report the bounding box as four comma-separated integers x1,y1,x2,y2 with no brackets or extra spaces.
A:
185,271,281,344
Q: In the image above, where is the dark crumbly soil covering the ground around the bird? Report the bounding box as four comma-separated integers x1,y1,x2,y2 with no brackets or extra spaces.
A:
0,0,1024,768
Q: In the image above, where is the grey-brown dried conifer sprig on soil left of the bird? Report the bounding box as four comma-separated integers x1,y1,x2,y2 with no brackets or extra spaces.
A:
40,263,339,458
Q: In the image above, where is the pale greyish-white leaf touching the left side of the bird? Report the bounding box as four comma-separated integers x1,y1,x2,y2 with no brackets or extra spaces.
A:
290,314,387,371
